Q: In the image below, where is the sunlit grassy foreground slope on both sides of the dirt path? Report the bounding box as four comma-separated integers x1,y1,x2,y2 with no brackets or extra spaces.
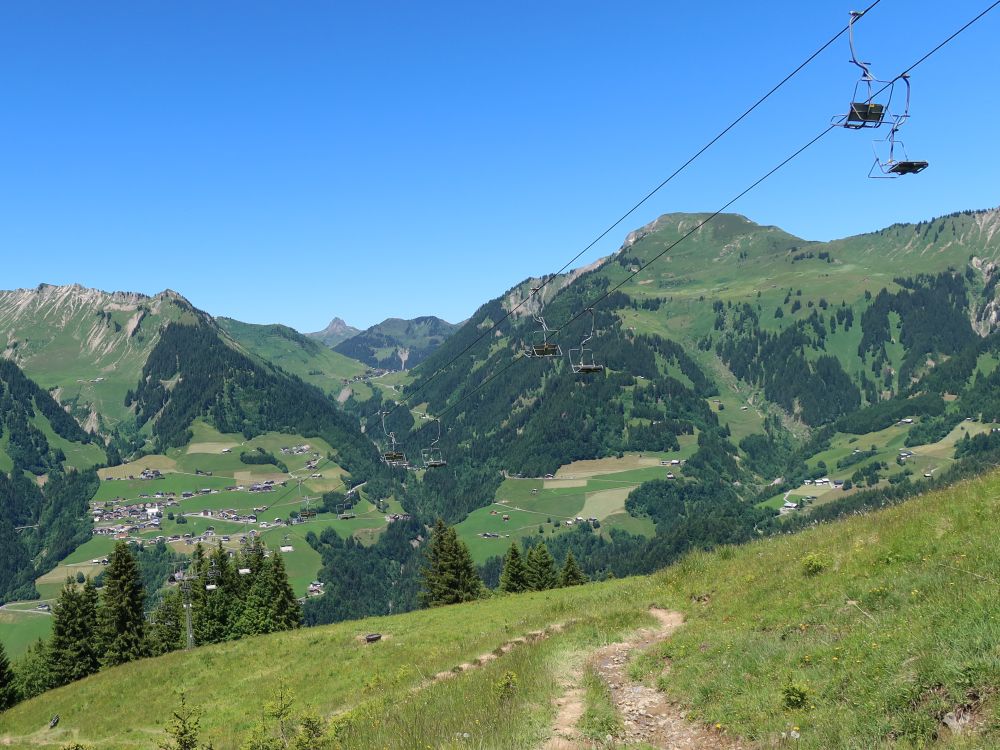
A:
0,474,1000,748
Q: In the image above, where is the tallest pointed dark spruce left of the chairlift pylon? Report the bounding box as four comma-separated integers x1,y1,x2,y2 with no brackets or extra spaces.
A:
99,542,146,666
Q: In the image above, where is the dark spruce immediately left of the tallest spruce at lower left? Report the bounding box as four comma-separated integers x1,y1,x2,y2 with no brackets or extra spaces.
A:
48,578,101,686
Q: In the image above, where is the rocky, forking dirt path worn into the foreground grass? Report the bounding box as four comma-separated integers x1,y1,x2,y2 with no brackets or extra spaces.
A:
543,608,743,750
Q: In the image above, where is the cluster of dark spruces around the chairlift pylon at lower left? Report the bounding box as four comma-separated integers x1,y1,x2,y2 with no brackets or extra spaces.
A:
0,540,302,710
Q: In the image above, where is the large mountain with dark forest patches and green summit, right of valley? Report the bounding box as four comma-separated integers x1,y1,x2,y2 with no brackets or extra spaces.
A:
328,206,1000,592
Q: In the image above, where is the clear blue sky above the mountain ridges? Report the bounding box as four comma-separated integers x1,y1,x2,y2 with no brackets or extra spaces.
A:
0,0,1000,331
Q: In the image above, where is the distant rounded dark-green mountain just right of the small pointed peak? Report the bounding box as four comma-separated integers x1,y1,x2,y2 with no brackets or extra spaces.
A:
333,315,461,370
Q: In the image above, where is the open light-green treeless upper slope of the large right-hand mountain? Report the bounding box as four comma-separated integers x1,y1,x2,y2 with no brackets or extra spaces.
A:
598,214,1000,434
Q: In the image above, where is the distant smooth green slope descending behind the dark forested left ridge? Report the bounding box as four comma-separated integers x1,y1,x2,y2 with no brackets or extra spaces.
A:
216,318,366,397
